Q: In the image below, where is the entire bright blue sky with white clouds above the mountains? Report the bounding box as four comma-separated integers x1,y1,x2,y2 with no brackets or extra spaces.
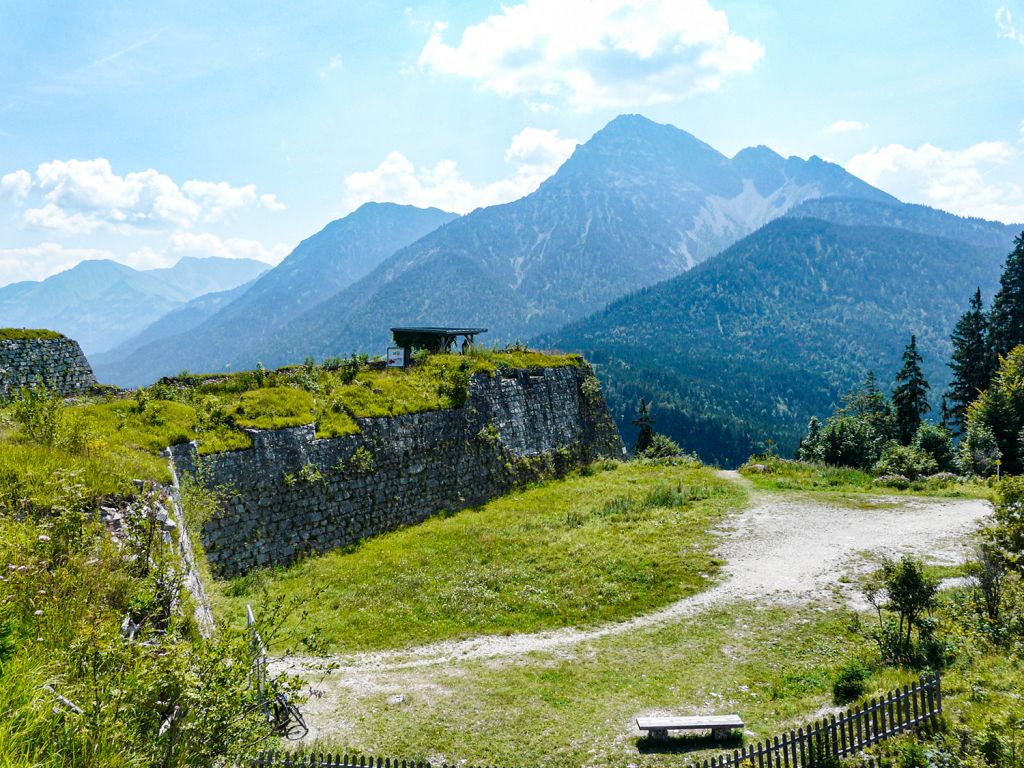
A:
0,0,1024,285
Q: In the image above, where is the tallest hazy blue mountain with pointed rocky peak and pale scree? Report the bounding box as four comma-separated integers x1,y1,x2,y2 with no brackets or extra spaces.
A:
249,116,894,362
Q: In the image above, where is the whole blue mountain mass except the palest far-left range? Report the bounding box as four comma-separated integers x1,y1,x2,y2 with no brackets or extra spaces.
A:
70,116,1020,464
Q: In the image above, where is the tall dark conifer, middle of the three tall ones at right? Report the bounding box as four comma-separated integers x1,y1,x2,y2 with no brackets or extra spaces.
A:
942,288,992,431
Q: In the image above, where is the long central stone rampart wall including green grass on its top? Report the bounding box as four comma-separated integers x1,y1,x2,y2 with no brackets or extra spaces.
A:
172,355,623,575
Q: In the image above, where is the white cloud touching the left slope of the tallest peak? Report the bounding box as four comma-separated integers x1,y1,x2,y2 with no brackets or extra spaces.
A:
345,128,577,213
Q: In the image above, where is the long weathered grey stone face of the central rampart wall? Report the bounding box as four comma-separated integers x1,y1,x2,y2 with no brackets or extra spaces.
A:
170,364,624,577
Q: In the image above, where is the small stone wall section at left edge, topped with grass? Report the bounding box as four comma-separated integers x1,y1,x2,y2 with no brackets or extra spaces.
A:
0,336,96,398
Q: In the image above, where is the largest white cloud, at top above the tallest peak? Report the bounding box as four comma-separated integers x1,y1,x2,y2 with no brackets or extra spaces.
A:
419,0,764,110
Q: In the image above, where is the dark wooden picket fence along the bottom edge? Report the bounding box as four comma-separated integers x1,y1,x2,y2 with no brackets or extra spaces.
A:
249,674,942,768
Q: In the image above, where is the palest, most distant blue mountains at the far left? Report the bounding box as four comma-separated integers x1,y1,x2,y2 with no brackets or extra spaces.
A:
0,258,269,355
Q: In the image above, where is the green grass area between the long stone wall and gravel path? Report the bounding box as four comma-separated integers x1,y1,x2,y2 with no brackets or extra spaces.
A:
216,462,744,651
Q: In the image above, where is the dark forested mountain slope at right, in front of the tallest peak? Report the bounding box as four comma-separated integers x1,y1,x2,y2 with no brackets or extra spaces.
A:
539,200,1015,464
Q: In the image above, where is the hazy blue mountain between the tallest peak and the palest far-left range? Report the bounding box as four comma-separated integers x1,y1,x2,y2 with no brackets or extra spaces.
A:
96,203,456,386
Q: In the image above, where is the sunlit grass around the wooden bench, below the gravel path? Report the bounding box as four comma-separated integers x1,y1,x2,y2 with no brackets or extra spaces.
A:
296,603,889,768
